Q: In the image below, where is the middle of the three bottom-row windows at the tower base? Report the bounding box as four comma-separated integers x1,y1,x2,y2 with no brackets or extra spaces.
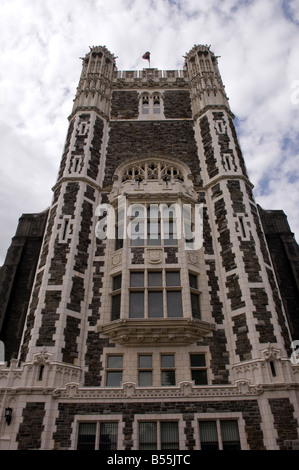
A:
139,421,179,450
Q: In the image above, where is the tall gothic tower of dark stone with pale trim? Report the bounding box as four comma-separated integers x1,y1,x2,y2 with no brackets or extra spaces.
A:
0,46,298,451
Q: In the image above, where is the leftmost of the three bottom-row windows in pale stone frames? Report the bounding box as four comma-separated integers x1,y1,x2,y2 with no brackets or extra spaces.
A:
77,422,118,450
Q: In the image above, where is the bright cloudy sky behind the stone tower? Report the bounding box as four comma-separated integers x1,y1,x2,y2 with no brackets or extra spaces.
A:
0,0,299,265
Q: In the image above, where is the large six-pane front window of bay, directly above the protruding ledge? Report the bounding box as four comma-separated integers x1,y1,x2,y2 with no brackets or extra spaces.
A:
129,270,183,318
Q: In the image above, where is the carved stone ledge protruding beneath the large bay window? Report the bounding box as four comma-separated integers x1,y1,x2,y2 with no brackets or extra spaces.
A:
97,318,215,346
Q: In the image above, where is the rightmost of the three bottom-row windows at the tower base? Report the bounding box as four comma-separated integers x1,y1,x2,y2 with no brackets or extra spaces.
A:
199,420,241,450
